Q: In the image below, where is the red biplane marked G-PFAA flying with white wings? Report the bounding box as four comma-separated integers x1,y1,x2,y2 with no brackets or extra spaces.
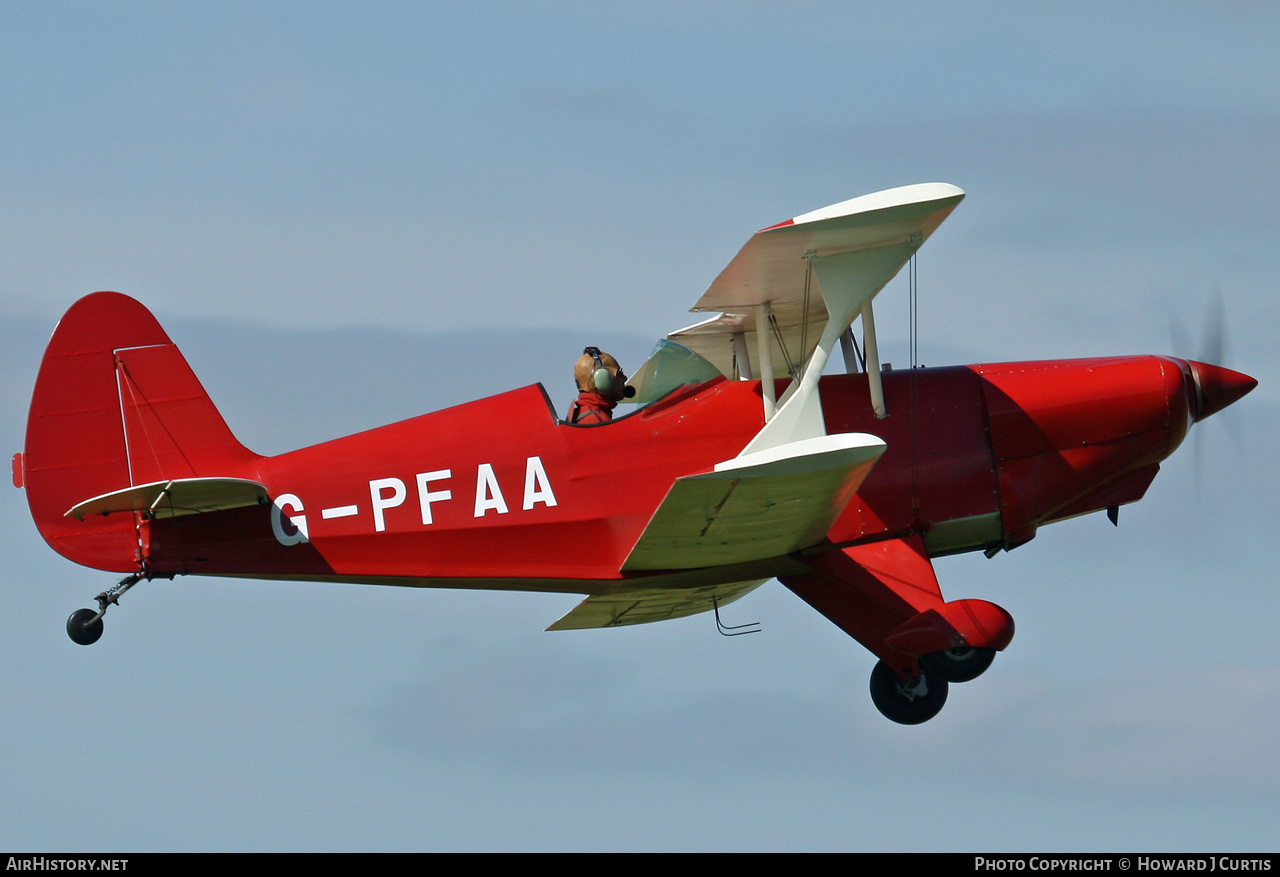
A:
14,183,1257,723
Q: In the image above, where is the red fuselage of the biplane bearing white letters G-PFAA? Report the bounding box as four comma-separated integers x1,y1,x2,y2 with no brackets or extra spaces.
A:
132,356,1218,593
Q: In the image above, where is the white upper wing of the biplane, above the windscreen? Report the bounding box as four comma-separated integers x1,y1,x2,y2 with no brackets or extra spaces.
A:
668,183,964,376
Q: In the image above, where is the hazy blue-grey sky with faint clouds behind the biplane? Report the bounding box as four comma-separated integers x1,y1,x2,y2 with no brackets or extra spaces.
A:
0,3,1280,851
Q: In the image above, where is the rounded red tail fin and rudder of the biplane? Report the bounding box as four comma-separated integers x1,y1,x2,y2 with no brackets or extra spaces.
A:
14,292,257,572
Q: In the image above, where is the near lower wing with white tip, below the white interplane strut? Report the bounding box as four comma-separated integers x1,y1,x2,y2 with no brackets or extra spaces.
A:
622,433,884,571
